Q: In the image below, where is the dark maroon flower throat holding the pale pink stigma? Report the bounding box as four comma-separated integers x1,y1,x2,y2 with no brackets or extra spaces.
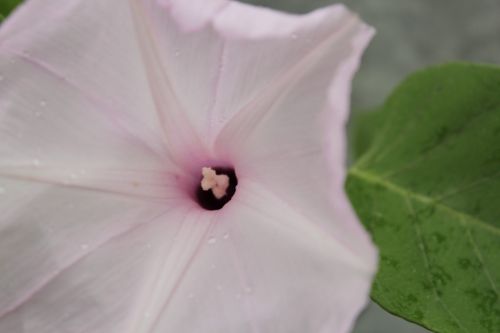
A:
196,167,238,210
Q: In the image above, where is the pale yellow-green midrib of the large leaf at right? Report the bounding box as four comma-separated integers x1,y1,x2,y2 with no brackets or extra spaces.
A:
349,167,500,237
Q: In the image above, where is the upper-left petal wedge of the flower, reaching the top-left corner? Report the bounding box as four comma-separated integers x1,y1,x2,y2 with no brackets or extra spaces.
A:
0,0,162,147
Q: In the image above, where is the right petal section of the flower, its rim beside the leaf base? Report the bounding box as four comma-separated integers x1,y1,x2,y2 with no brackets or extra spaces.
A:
216,6,374,257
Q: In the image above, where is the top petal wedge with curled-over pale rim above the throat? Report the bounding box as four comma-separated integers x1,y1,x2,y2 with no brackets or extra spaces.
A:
133,0,359,141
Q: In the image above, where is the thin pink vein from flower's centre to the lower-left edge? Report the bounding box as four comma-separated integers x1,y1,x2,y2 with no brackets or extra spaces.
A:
0,211,172,320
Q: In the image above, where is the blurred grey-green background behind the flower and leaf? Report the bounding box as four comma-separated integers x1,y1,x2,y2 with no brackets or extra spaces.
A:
0,0,500,333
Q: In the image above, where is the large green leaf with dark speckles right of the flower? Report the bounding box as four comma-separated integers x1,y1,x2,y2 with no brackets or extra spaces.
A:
346,64,500,333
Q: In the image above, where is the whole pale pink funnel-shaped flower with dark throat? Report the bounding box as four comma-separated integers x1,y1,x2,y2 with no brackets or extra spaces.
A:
0,0,376,333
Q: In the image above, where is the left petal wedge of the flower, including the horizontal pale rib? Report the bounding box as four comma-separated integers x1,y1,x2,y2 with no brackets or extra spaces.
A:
0,52,182,199
